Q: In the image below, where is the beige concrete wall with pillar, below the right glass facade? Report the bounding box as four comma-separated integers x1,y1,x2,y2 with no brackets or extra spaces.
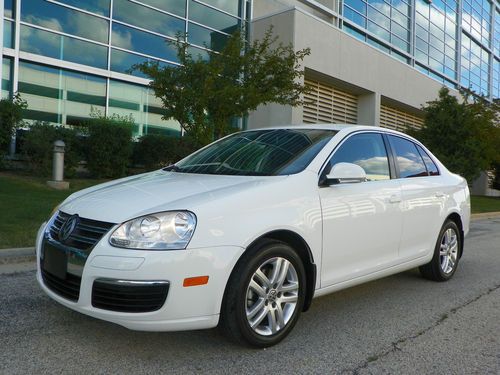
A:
249,4,456,127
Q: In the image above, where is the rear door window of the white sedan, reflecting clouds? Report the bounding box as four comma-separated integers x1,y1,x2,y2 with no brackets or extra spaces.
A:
389,135,428,178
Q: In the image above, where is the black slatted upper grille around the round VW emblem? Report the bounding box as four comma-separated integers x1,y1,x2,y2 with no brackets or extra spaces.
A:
49,211,115,250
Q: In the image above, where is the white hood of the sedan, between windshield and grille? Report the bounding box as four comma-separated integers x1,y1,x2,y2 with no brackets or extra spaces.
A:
60,170,285,223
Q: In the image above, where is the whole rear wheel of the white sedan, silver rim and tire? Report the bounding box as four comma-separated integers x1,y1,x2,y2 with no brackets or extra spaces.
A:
420,220,462,281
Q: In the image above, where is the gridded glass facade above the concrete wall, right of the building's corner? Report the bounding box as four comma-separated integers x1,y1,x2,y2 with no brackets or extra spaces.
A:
341,0,500,99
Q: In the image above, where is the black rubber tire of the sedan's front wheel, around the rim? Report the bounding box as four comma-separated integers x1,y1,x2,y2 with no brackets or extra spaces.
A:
219,240,306,348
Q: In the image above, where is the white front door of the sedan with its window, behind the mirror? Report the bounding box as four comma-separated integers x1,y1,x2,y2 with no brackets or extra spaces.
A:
319,132,402,287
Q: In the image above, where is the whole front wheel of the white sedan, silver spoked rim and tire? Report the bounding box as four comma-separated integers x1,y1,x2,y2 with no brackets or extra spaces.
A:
221,241,306,347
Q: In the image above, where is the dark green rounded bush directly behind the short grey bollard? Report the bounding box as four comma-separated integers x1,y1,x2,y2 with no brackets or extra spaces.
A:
21,122,82,177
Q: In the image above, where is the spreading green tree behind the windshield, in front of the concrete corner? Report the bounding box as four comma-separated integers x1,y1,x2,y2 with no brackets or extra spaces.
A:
133,28,310,144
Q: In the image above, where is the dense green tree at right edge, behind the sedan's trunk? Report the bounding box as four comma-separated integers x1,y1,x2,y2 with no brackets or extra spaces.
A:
412,87,500,184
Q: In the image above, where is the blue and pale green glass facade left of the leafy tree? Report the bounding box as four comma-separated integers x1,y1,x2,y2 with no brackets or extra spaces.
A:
0,0,250,135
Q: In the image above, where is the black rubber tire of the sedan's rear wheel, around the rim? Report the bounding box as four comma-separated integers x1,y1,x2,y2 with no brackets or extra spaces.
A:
419,220,462,281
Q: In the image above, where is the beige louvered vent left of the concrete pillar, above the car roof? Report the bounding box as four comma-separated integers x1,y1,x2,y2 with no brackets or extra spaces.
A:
303,78,358,124
